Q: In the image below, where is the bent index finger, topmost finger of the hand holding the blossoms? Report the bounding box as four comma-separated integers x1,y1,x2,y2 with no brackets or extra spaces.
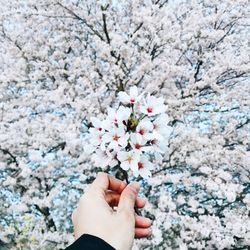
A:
90,172,127,194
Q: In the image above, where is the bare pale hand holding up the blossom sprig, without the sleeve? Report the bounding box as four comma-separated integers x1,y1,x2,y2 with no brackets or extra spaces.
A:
72,173,151,250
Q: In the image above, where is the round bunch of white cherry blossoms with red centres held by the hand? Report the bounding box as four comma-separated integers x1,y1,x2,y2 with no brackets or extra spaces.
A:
85,86,172,178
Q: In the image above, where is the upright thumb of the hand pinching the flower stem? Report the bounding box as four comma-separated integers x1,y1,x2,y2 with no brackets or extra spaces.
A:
117,182,140,214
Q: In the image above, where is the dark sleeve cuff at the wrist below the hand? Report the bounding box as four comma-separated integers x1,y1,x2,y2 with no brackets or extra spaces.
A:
65,234,115,250
